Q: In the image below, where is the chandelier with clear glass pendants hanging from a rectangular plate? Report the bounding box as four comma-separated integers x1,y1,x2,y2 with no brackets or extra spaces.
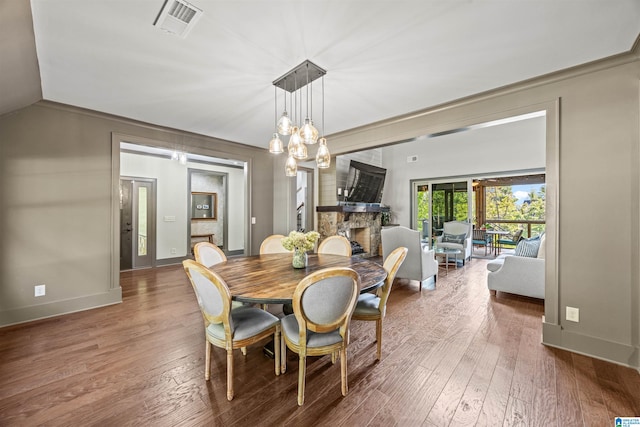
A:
269,60,331,176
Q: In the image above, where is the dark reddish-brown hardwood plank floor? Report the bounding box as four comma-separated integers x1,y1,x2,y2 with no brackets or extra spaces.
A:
0,259,640,427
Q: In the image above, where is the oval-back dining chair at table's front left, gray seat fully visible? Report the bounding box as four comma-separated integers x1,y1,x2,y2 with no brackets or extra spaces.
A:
182,260,281,400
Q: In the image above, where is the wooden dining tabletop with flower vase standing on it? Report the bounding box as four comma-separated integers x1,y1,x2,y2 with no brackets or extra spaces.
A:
209,253,387,304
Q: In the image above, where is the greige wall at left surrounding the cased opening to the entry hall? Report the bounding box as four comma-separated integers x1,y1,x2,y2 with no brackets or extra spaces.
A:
0,102,273,326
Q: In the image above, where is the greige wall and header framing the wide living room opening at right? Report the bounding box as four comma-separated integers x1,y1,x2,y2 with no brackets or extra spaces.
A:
320,51,640,367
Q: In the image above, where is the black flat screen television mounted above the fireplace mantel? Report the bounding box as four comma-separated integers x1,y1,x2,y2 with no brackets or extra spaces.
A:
345,160,387,203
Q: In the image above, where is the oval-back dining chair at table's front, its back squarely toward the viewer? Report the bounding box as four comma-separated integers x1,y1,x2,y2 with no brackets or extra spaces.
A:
281,267,360,406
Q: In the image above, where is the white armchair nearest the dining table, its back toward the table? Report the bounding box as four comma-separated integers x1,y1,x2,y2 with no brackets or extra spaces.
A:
381,226,438,291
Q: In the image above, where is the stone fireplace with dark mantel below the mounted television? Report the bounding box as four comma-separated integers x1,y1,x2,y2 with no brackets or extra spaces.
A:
316,205,385,258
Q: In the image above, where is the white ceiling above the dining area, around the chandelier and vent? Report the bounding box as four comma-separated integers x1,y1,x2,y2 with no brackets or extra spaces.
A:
31,0,640,148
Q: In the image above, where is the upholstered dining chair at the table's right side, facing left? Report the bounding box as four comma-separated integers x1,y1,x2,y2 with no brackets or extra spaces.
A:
351,247,409,360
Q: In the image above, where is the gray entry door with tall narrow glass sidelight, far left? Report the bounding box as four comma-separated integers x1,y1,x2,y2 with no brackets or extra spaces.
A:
120,177,156,271
